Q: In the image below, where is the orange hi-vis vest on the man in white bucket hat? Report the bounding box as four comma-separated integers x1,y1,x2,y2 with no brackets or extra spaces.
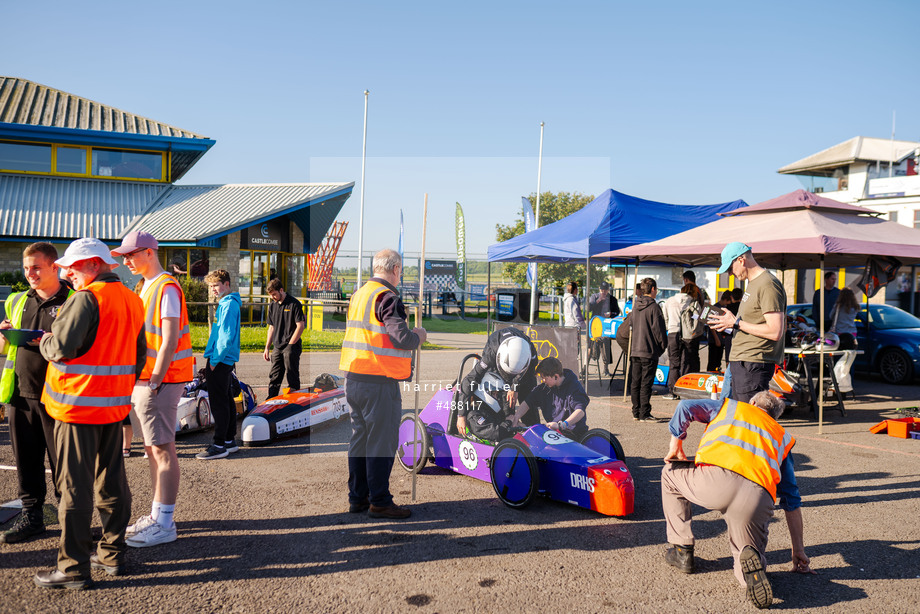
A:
42,281,144,424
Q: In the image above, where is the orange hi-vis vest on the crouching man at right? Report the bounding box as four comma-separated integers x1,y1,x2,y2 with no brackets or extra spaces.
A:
696,399,795,502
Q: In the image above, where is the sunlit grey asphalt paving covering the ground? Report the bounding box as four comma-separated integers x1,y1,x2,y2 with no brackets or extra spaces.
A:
0,335,920,614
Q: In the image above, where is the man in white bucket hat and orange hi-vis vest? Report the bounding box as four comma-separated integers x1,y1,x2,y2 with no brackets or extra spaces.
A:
35,239,147,589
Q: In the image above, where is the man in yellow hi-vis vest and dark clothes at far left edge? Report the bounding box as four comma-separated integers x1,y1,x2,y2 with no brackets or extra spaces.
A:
0,243,73,544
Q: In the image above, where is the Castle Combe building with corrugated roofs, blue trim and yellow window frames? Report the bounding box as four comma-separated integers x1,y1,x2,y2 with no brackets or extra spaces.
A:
0,76,354,319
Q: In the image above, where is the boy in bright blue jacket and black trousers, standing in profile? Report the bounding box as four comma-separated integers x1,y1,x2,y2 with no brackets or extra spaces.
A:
196,269,242,460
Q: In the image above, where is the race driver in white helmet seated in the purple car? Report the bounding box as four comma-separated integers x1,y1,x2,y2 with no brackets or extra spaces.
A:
457,327,539,441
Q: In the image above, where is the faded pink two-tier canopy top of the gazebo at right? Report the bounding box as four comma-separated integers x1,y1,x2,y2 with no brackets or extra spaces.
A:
592,190,920,269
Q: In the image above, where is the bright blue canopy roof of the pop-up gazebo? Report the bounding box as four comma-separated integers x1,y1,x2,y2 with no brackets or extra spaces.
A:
488,190,747,262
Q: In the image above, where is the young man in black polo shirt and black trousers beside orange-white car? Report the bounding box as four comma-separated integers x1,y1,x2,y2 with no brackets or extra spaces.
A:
262,279,304,398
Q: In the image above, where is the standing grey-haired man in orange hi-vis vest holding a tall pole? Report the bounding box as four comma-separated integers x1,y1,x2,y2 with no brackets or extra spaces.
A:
339,249,427,520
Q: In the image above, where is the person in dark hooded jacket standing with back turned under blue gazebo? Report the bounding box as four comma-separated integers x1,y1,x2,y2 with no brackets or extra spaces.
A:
617,277,668,422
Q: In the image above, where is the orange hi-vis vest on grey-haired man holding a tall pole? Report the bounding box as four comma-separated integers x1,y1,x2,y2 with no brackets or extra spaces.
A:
339,281,412,380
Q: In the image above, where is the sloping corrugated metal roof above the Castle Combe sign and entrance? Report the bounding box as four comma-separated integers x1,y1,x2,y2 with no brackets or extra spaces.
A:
122,182,355,243
